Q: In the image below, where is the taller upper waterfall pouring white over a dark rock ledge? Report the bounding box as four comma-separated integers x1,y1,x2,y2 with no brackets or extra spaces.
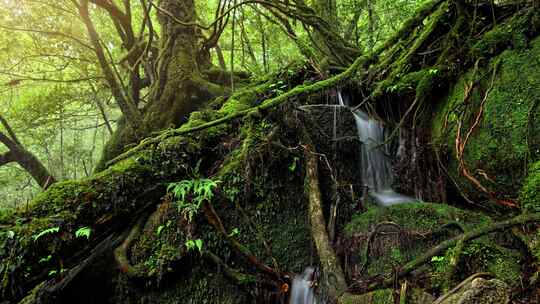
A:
338,92,414,206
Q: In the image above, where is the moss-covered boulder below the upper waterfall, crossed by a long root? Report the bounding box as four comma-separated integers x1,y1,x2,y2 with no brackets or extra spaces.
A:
346,203,522,290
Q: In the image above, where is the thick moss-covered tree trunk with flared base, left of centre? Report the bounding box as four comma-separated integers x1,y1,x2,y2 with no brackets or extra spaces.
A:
96,0,226,171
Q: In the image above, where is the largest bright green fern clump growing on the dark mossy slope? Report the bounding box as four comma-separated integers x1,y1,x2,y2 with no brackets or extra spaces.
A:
167,178,219,222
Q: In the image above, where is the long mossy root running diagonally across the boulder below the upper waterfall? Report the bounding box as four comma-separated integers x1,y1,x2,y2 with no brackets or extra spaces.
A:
367,213,540,291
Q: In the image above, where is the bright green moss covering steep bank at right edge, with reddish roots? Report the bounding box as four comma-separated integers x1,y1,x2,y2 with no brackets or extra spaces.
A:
432,38,540,201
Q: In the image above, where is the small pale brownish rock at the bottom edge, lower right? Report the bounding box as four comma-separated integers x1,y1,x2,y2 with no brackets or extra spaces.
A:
435,278,510,304
